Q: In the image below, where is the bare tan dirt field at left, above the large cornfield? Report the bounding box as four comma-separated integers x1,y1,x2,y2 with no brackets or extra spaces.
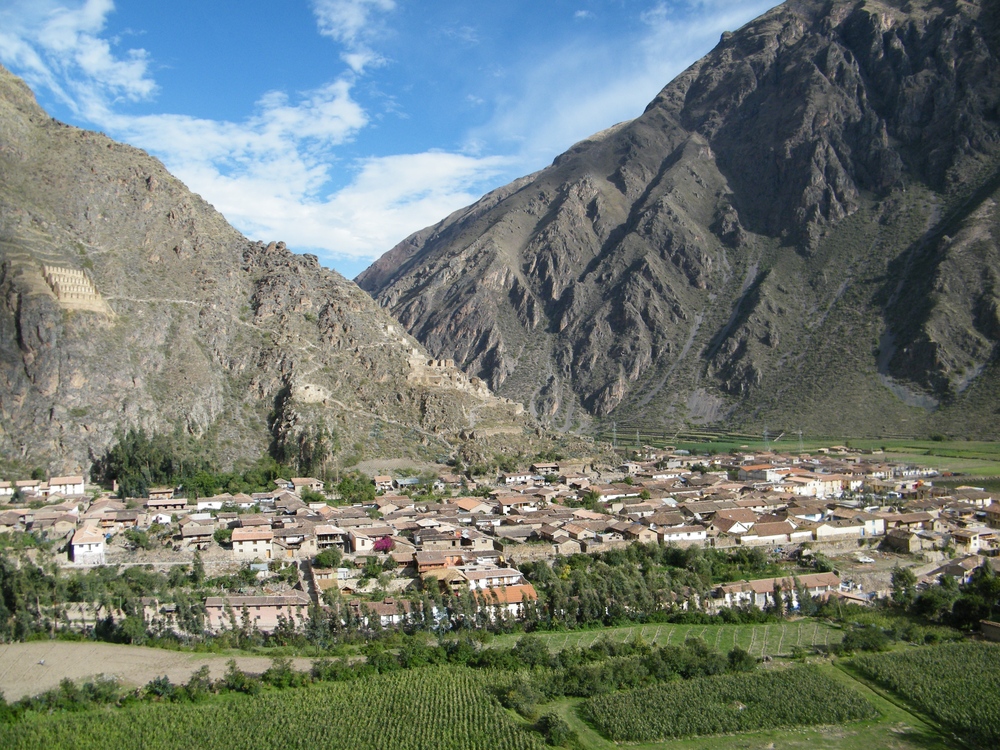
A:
0,641,312,701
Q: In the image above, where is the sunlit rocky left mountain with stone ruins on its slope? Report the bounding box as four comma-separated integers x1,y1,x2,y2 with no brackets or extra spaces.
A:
0,68,533,473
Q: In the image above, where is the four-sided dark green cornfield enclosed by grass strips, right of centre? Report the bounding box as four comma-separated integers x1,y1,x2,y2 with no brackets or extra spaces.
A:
584,667,878,742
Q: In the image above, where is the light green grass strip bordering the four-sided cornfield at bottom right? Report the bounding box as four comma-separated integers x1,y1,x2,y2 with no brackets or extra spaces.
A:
540,665,955,750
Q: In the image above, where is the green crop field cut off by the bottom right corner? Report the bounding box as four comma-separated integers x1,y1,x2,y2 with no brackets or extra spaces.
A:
852,643,1000,750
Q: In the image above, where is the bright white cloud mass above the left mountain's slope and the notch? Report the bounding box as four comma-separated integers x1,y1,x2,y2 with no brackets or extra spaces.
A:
0,0,504,268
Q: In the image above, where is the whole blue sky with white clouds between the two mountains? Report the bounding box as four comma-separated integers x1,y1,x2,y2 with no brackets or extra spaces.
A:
0,0,776,277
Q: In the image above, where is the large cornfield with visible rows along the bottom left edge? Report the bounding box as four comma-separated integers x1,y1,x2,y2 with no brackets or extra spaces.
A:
3,668,544,750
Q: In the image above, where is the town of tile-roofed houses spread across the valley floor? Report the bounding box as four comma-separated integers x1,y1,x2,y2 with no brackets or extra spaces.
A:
0,446,1000,633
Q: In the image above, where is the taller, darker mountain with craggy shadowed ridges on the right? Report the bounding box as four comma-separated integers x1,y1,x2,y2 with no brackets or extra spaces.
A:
357,0,1000,436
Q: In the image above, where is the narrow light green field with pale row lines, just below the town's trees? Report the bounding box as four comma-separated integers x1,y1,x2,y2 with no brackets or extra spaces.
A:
493,620,843,657
